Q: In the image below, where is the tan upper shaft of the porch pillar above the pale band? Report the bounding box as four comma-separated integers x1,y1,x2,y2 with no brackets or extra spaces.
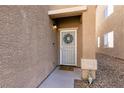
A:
82,6,96,59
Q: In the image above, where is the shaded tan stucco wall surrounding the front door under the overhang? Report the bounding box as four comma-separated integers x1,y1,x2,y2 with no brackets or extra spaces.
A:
56,16,82,67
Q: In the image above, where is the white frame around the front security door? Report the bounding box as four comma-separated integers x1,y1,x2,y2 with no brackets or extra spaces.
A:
59,28,78,66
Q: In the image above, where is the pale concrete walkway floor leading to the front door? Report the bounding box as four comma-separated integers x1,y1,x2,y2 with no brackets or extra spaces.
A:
40,67,81,88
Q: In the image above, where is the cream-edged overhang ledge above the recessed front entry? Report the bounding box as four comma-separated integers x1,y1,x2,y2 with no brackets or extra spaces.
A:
48,6,87,19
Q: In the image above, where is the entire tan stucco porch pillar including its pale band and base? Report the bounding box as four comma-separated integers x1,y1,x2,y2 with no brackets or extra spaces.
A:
81,6,97,80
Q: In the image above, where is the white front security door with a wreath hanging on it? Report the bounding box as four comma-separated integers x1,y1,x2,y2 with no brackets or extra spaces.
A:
60,29,77,66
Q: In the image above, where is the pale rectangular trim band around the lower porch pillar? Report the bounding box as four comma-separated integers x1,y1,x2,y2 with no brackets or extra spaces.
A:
81,59,97,70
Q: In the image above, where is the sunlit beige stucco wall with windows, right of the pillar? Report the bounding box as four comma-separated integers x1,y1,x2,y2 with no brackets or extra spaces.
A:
97,6,124,59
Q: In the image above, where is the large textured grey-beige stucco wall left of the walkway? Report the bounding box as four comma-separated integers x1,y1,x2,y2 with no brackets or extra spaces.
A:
0,6,57,87
